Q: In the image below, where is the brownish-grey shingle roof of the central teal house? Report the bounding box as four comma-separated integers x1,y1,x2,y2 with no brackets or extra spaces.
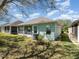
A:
19,17,54,25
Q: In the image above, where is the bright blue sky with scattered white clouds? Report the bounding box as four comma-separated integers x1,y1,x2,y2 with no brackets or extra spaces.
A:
6,0,79,21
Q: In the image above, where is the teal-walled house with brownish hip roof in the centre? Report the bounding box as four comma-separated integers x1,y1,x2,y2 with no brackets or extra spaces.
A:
18,17,62,40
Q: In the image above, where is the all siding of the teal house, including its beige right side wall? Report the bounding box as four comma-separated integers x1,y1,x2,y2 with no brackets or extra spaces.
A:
18,23,61,40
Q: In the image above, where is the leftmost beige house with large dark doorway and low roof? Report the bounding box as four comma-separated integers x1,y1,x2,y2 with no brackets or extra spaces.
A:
0,20,23,34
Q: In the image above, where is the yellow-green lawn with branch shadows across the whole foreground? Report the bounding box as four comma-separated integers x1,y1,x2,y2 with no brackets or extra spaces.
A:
0,33,79,59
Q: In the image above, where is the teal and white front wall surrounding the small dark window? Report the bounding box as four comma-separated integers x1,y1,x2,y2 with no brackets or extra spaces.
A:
33,24,55,40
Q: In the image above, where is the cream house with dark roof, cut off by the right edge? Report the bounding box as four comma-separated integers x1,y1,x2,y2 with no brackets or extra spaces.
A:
68,20,79,42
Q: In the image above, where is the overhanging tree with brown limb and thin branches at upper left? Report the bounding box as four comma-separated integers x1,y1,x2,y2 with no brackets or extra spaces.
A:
0,0,55,21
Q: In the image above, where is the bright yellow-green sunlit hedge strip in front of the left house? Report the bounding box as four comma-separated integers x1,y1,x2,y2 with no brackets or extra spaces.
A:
0,33,25,42
